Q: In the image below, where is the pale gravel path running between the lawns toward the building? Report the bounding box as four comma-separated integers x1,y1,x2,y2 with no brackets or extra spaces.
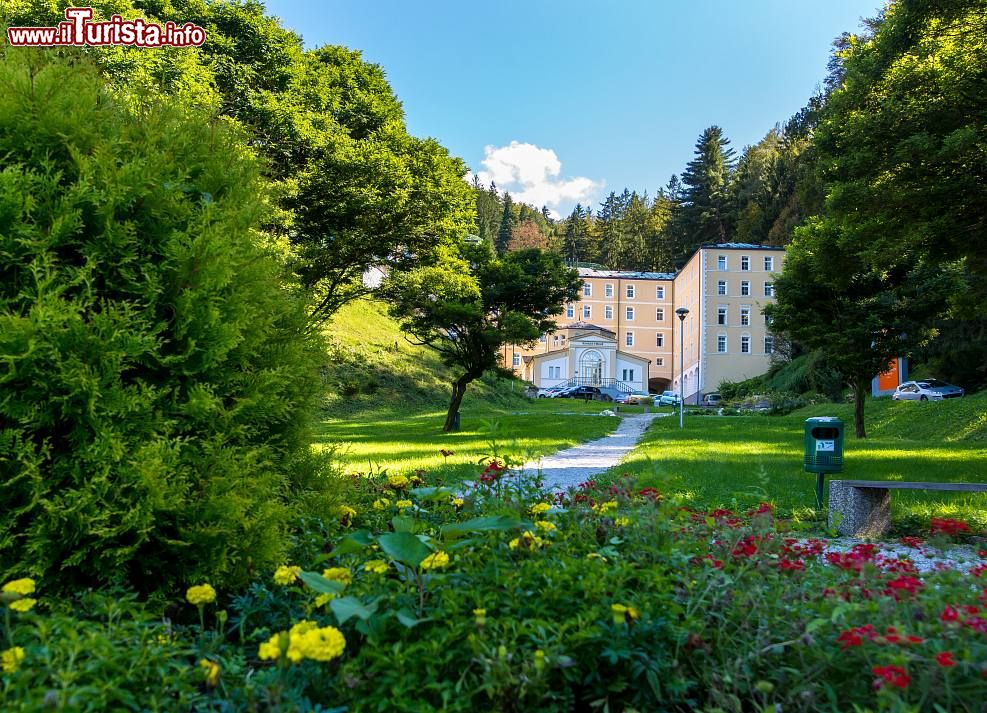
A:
524,413,671,492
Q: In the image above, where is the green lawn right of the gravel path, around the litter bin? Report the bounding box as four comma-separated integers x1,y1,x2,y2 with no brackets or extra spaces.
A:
610,394,987,526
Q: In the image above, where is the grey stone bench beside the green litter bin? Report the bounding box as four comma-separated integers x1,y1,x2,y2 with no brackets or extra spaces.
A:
829,480,987,537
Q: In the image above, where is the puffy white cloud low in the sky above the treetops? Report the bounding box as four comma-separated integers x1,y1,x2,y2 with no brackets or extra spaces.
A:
477,141,604,217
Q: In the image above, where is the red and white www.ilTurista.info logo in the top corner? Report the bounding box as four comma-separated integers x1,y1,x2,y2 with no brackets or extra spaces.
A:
7,7,206,47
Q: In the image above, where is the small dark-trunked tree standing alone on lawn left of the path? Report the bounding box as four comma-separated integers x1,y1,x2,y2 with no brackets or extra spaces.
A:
386,243,580,432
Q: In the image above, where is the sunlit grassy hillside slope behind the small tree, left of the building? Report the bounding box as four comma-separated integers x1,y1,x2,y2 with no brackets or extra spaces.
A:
324,300,526,418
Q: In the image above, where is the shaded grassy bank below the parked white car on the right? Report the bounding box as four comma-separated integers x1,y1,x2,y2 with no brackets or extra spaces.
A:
792,391,987,443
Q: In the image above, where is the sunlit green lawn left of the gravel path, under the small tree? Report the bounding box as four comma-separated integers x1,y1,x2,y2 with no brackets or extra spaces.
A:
317,399,620,480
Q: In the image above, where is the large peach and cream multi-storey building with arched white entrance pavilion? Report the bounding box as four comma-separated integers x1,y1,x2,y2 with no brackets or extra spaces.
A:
502,243,785,403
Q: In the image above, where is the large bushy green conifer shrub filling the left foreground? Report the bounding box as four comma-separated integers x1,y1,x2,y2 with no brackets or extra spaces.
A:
0,51,325,590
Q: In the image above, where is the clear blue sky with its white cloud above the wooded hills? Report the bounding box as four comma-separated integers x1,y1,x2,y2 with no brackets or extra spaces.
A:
266,0,882,214
